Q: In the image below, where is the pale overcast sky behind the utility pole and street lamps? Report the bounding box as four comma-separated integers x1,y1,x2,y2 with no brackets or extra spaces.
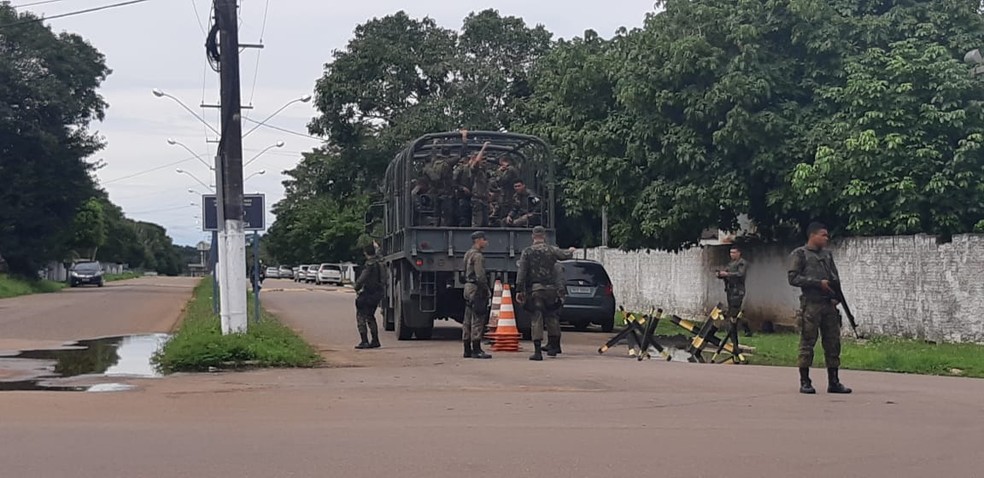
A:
12,0,653,245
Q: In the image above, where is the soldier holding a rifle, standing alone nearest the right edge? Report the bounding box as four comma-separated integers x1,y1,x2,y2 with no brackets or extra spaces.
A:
789,222,851,394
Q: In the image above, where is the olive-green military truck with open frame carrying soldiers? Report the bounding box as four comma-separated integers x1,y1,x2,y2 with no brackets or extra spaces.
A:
367,131,555,340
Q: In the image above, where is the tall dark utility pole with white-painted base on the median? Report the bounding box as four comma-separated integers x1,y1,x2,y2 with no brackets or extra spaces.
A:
214,0,247,334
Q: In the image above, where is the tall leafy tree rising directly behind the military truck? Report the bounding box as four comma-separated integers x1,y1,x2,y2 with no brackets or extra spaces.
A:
267,10,550,263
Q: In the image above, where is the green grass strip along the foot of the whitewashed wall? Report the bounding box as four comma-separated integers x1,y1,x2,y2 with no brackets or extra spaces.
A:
616,317,984,378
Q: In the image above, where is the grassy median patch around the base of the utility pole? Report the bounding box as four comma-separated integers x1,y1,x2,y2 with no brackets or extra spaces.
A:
153,280,321,373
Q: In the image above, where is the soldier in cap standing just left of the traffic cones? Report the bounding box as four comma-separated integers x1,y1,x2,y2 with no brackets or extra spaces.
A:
461,231,492,359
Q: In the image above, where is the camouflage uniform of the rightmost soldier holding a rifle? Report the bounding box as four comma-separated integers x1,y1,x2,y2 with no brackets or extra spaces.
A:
788,246,841,368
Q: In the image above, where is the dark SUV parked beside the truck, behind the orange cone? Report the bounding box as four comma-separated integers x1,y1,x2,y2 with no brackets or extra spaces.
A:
559,259,615,332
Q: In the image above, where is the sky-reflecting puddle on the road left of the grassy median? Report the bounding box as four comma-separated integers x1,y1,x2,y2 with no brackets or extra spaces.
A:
0,334,170,392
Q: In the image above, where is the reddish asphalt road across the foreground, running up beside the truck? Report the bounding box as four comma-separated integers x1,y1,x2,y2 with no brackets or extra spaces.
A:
0,280,984,478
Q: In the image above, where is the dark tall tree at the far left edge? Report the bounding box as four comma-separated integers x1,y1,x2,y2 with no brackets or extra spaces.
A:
0,3,110,277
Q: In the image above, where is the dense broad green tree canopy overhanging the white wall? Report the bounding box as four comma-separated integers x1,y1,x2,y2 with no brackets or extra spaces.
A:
527,0,984,250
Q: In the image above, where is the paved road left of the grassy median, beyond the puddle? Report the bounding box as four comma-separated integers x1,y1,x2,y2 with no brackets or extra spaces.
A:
0,277,197,350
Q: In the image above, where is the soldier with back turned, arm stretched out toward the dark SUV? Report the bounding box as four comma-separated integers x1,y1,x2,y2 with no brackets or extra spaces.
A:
516,226,574,360
